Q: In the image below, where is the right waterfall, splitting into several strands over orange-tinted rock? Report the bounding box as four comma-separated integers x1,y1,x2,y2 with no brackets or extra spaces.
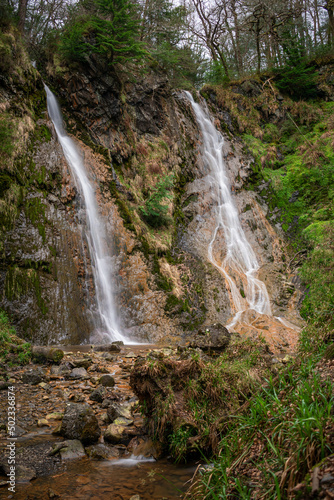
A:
185,91,271,327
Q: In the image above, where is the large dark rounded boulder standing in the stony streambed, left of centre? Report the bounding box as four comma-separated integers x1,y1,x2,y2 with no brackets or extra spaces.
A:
60,403,101,444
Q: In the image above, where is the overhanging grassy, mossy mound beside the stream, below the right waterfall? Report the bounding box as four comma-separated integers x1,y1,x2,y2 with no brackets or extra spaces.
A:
132,339,270,462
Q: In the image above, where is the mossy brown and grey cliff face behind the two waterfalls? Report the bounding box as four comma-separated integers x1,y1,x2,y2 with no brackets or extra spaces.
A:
0,37,298,346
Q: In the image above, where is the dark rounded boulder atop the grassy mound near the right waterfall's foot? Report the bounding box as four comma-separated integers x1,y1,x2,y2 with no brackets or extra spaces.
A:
190,323,231,354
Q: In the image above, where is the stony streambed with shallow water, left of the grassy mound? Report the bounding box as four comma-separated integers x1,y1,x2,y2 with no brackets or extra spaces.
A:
0,343,194,500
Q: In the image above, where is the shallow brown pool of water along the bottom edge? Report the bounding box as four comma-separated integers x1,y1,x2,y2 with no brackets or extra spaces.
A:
14,459,195,500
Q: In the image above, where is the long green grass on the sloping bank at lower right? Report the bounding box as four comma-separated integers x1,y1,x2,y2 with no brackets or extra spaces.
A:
192,327,334,500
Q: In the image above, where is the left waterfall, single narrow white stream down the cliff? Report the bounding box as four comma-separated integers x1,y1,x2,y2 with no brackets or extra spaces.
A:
44,85,127,342
